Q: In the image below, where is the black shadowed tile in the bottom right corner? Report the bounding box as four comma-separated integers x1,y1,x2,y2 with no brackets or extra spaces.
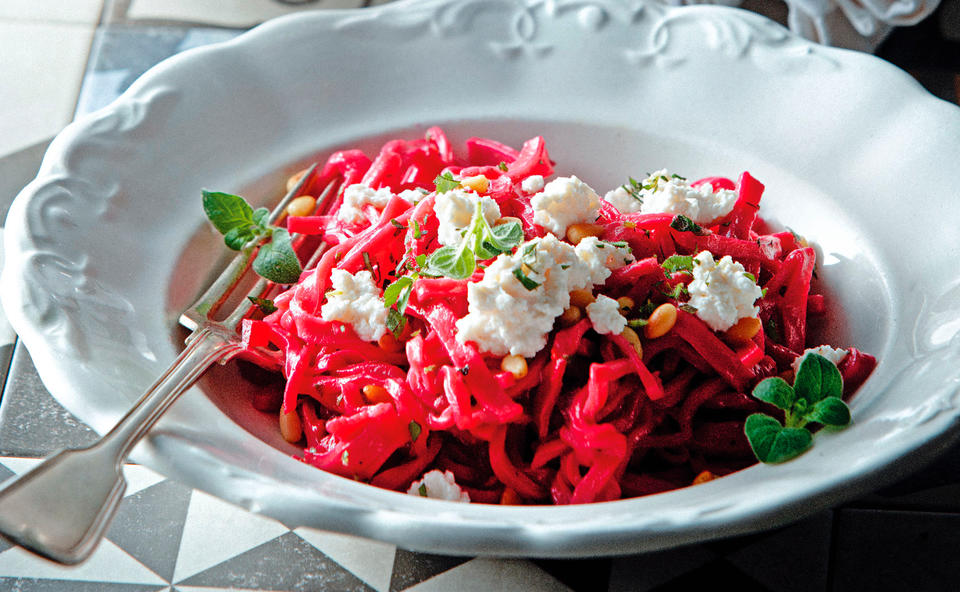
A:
831,509,960,592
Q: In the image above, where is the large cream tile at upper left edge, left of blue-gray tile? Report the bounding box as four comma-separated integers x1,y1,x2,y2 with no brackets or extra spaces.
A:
0,21,94,155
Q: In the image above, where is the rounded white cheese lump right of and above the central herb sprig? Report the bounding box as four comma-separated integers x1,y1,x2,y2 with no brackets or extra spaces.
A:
530,176,600,236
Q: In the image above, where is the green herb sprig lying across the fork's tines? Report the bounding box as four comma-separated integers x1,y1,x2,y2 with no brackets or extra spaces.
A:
203,191,303,284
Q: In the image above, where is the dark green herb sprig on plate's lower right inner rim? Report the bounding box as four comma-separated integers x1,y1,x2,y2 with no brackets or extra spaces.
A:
744,353,850,463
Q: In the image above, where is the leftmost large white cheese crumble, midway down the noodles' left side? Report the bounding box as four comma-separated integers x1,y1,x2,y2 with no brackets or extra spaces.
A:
320,269,388,341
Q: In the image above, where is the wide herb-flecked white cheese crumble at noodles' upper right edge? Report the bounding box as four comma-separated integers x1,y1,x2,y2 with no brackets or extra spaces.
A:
628,169,737,225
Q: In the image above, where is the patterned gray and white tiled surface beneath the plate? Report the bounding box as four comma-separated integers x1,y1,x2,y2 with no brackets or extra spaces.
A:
0,0,960,592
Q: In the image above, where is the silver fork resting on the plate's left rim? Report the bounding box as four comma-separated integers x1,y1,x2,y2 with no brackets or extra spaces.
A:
0,168,338,564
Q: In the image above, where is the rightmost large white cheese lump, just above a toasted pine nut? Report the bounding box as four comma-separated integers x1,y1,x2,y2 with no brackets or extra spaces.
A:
687,251,762,331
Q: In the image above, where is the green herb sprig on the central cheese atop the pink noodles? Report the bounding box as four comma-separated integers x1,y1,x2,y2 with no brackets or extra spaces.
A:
423,201,523,280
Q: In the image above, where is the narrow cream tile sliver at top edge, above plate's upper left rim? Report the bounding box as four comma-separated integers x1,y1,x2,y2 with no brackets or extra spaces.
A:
127,0,363,27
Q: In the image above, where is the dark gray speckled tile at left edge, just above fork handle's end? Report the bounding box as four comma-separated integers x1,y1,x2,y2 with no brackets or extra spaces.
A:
0,345,97,457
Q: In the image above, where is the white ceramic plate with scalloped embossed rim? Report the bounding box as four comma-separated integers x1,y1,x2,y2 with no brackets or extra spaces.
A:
3,0,960,556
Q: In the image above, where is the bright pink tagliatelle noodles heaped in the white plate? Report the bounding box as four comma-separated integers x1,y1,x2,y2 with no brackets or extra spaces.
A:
234,128,876,504
